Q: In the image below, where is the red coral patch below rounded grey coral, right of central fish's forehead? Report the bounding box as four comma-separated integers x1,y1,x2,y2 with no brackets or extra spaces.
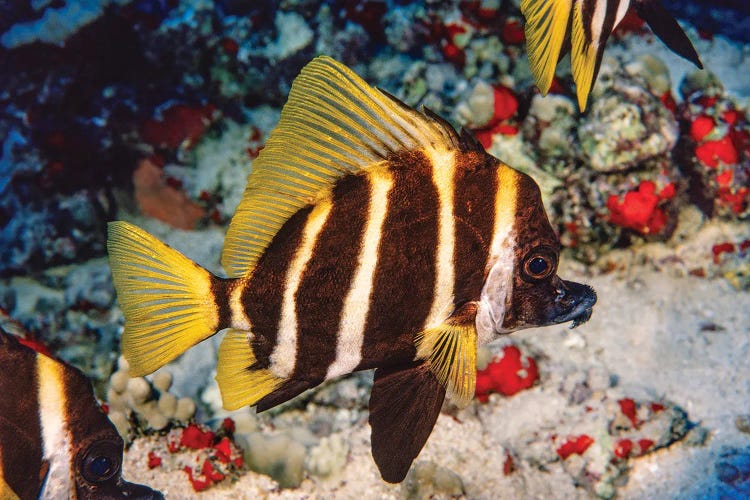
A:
607,181,674,234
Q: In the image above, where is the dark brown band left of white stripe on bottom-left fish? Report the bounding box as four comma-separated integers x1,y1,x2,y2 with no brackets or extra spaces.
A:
0,340,42,498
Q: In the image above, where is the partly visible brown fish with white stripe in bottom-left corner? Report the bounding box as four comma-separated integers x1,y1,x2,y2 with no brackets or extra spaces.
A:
0,330,164,500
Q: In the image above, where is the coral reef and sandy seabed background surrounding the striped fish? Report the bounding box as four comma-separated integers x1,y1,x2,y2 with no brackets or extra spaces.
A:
0,0,750,498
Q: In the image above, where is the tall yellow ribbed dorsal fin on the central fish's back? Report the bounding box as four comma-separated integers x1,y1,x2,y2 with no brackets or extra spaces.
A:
221,56,458,277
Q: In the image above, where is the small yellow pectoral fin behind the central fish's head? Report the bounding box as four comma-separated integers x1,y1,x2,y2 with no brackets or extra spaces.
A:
416,323,477,408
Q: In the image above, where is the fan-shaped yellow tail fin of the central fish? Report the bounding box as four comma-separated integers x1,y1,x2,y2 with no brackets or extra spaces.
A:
107,221,219,376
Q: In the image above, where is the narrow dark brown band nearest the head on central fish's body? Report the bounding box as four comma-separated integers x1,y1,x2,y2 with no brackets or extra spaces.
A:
453,152,498,305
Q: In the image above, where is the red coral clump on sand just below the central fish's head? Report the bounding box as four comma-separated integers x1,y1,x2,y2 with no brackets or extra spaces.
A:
476,346,539,402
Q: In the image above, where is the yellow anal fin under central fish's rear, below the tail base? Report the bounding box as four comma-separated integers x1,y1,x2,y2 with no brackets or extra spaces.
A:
216,329,284,410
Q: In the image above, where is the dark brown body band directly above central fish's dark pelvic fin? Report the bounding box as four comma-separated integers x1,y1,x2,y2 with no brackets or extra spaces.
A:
358,151,438,369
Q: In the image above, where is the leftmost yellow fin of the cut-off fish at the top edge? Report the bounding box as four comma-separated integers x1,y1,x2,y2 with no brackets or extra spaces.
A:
521,0,573,95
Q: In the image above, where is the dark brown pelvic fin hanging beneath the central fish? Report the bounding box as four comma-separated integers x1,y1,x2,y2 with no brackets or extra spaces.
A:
370,363,445,483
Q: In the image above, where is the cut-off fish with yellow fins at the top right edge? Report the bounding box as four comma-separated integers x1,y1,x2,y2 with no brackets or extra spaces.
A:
521,0,703,111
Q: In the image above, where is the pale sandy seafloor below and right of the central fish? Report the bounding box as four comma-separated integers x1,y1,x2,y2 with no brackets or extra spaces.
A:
119,216,750,499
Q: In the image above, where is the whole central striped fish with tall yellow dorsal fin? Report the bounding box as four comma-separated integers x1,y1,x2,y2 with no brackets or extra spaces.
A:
108,57,596,482
